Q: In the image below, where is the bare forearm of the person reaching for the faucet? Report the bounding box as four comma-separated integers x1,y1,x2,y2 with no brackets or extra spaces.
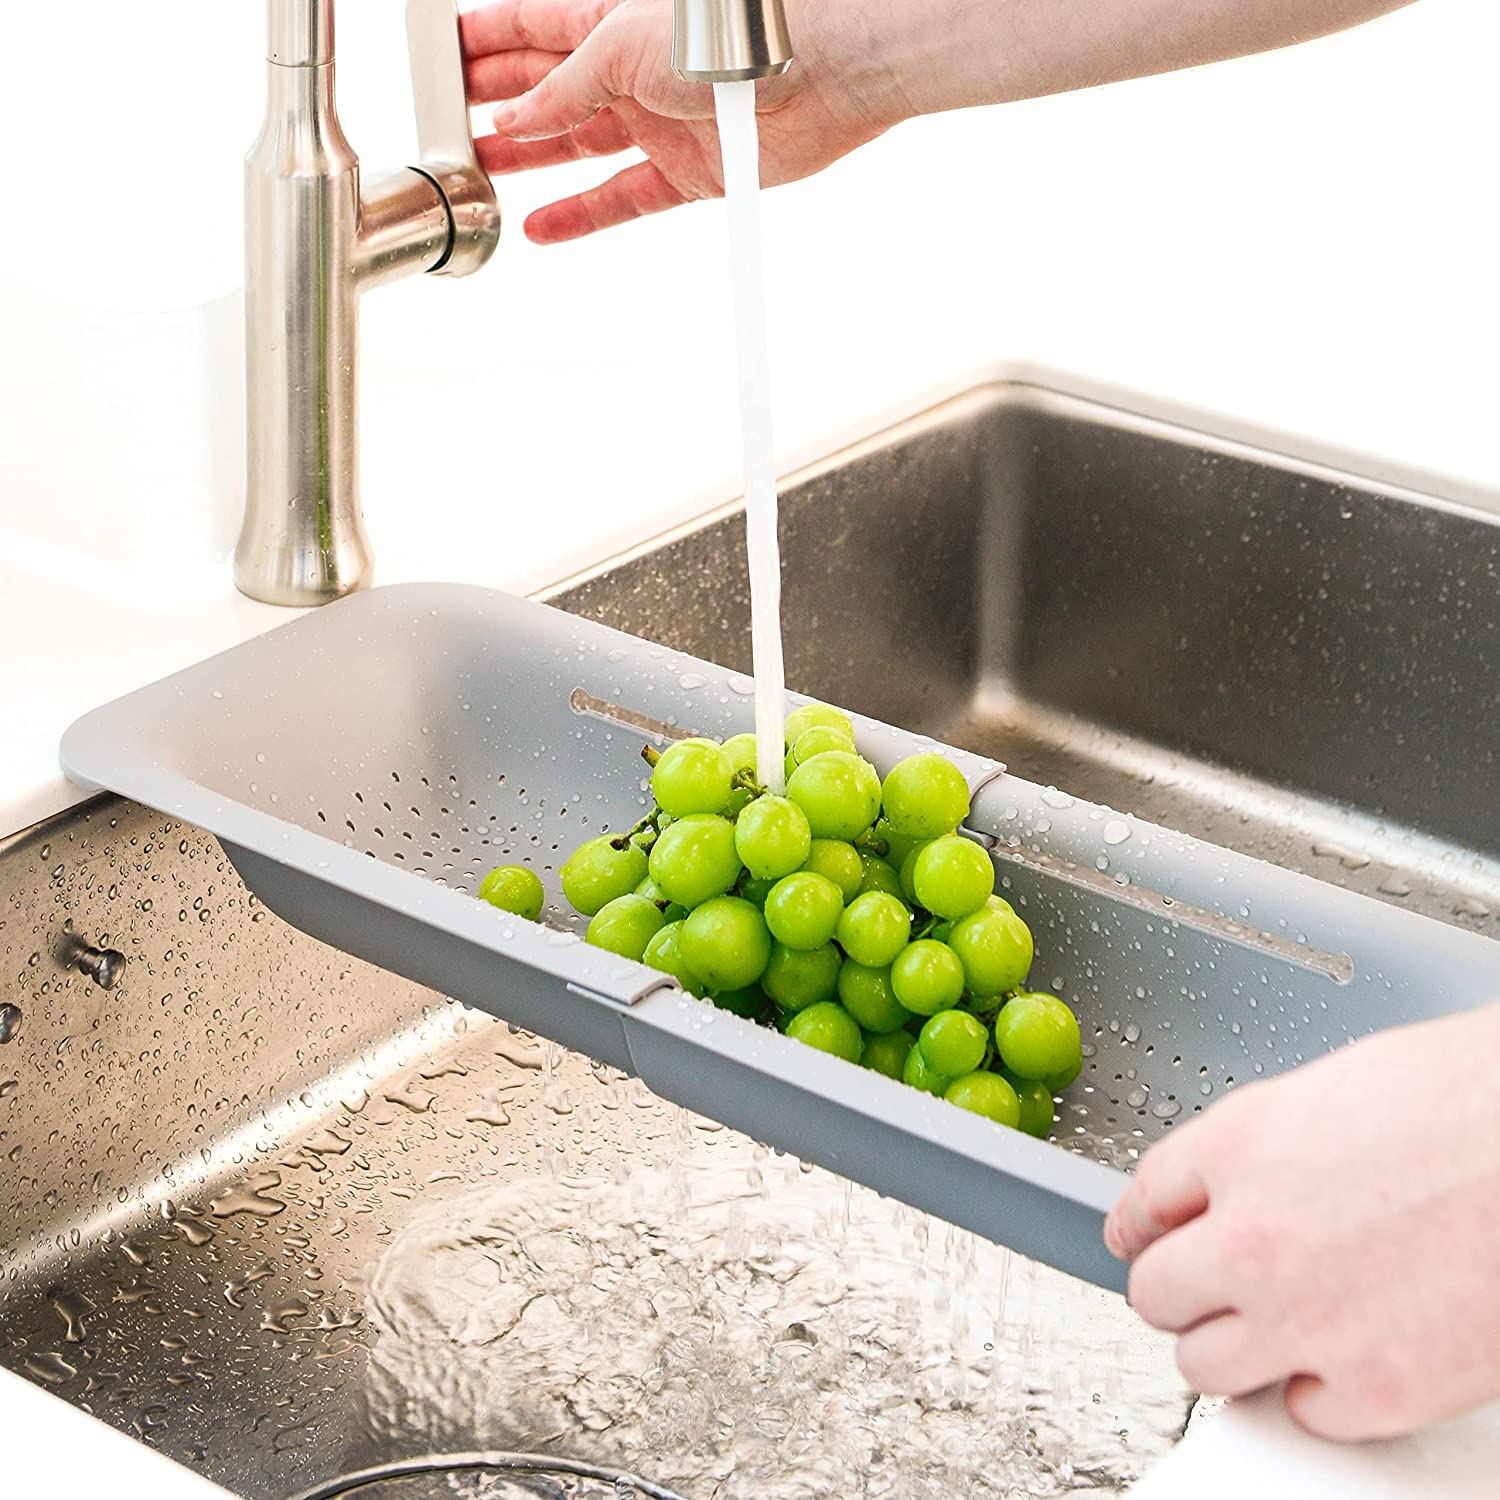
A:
864,0,1410,119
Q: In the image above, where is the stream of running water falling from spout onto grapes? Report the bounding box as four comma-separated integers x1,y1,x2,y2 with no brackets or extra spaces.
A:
714,83,786,794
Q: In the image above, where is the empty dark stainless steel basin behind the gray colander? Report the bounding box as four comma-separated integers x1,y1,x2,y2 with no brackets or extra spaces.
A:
551,384,1500,932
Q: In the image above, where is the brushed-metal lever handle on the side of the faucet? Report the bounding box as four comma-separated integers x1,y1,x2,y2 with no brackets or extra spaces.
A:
407,0,500,276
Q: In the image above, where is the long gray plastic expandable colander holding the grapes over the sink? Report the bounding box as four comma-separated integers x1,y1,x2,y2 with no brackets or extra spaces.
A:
62,585,1500,1287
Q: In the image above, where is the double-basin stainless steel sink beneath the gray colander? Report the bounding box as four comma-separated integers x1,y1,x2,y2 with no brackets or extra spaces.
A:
0,384,1500,1500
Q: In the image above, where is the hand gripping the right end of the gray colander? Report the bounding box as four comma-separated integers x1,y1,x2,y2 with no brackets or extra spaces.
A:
1104,1008,1500,1440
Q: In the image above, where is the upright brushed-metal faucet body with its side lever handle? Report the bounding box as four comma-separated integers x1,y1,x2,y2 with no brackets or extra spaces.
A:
234,0,500,605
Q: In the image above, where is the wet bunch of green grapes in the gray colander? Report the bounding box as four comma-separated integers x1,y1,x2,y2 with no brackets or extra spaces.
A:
480,704,1083,1137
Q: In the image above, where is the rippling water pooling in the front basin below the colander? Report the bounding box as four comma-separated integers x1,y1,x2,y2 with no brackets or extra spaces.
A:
365,1049,1188,1500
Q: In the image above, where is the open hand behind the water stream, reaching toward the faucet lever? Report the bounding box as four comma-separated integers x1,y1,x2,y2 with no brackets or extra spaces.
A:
462,0,903,245
